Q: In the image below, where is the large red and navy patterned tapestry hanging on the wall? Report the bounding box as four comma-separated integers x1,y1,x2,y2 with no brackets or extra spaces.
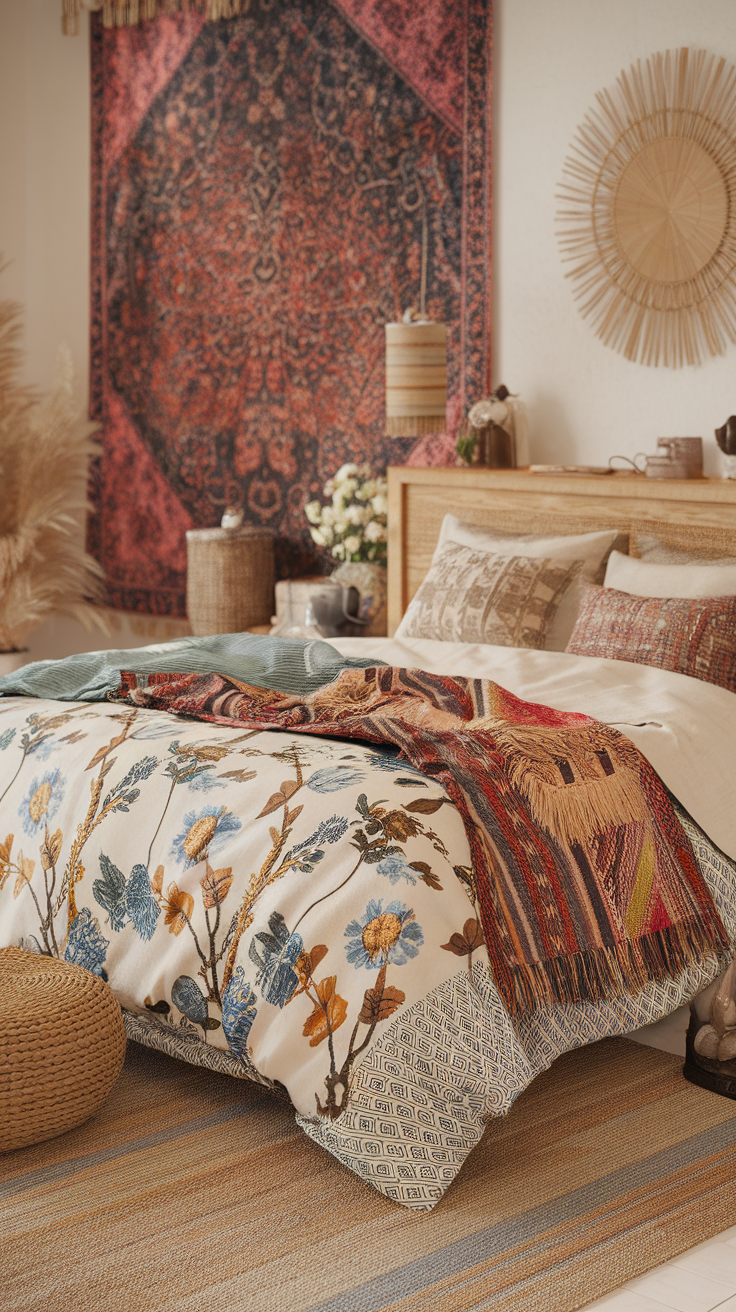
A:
89,0,491,615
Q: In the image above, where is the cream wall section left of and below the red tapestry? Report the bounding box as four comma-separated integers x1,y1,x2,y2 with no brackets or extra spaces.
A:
0,0,186,660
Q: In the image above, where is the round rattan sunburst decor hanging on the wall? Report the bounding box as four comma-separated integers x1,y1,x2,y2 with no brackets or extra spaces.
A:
558,49,736,367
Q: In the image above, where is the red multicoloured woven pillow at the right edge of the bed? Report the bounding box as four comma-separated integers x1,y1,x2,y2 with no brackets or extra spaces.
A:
565,584,736,693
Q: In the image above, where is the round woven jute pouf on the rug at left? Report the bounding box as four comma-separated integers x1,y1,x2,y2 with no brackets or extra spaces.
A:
0,947,126,1152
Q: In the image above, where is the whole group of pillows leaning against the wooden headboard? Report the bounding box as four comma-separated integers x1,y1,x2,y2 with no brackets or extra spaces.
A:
396,514,736,691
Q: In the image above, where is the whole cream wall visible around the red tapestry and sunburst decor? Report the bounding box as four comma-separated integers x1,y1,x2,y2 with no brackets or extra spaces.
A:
0,0,736,656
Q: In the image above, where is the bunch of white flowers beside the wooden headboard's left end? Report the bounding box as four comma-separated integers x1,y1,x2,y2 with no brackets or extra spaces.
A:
304,464,388,564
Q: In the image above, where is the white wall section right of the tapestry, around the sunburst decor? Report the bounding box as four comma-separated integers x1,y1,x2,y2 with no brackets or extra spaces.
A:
493,0,736,474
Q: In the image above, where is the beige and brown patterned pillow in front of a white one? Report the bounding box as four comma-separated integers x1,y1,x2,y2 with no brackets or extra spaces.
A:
396,542,580,649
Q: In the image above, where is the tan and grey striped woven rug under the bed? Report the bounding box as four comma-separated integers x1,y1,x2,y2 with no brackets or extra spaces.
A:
0,1039,736,1312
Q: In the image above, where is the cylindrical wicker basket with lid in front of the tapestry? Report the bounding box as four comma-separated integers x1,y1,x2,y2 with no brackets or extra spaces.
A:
186,527,273,638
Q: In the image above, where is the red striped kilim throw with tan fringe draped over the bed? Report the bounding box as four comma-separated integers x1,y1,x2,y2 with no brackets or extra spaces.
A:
121,666,727,1013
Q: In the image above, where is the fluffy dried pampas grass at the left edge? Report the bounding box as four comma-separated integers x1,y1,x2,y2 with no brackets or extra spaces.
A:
0,280,106,652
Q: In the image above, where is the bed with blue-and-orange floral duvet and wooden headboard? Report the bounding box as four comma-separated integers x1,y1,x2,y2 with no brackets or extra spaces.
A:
0,471,736,1210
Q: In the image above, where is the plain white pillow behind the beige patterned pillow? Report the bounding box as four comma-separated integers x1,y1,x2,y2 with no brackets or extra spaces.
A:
419,514,619,652
